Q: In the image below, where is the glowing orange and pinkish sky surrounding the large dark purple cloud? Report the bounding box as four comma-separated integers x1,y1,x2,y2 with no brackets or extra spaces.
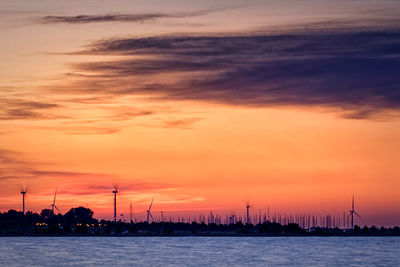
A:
0,1,400,225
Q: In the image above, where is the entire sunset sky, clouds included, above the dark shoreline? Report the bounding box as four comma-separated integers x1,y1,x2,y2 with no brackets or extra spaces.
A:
0,0,400,226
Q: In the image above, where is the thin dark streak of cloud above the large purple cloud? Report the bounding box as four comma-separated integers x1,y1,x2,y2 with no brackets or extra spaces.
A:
38,9,225,24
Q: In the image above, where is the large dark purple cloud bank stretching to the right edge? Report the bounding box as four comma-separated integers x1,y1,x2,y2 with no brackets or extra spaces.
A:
61,21,400,119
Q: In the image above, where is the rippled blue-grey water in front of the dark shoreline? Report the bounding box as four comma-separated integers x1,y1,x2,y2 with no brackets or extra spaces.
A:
0,237,400,266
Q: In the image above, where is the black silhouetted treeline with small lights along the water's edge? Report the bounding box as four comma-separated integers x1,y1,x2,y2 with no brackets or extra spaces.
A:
0,207,400,236
